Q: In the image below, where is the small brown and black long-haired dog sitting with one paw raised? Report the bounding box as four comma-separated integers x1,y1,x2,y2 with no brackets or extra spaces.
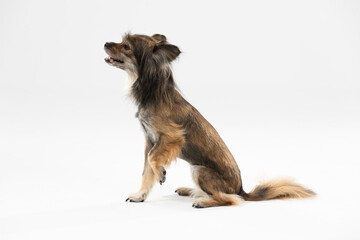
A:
104,34,315,208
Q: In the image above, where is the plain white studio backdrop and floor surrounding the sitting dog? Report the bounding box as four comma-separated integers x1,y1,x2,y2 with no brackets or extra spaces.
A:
0,0,360,240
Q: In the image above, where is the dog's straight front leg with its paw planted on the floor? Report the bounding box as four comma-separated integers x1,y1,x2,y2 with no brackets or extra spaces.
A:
126,140,156,202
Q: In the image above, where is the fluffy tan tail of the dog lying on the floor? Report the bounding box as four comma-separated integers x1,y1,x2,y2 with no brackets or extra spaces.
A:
239,179,316,201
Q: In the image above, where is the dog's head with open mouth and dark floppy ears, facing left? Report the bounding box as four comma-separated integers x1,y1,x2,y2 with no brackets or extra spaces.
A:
104,34,180,76
